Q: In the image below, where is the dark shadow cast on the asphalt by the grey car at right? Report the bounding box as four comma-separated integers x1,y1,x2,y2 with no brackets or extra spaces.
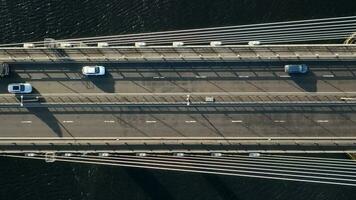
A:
290,71,317,92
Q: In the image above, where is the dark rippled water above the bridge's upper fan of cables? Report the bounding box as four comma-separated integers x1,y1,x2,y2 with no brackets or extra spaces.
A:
0,0,356,43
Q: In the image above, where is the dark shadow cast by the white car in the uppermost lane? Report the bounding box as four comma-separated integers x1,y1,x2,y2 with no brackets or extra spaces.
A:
87,72,115,93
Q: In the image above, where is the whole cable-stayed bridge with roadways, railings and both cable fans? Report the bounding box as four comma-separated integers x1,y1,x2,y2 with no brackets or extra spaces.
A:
0,16,356,186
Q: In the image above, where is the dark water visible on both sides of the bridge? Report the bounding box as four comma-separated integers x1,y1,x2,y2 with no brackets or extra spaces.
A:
0,0,356,200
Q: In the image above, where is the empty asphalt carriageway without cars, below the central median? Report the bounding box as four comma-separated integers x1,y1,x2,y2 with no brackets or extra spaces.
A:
0,106,356,137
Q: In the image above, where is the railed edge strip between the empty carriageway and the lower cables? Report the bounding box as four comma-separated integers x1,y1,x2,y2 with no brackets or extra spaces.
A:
0,137,356,153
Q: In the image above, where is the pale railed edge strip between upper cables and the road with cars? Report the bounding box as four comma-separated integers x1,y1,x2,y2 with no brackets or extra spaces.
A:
0,45,356,63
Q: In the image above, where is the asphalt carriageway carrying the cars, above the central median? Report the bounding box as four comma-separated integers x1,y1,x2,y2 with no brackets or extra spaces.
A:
0,62,356,93
